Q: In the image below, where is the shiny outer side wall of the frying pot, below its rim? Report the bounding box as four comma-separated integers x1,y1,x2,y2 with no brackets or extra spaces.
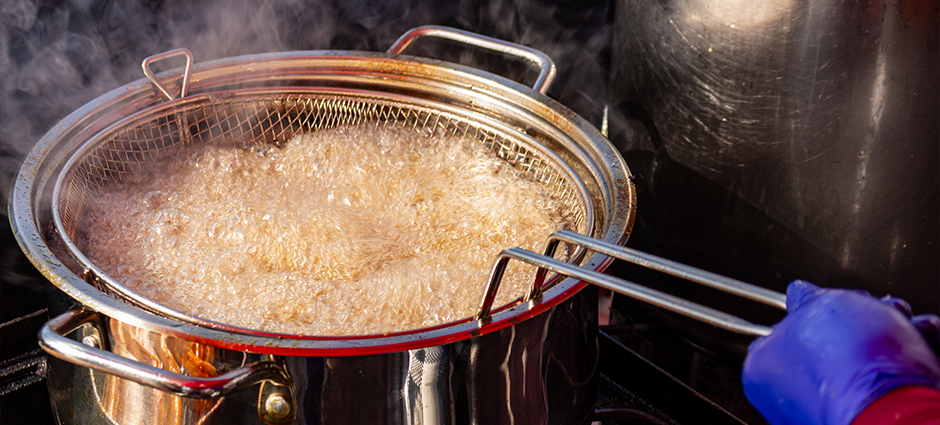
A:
42,291,598,425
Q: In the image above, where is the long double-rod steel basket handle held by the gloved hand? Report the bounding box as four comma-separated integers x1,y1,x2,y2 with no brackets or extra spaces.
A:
475,230,786,336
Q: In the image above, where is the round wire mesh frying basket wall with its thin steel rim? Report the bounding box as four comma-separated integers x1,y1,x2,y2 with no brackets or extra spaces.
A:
52,88,594,332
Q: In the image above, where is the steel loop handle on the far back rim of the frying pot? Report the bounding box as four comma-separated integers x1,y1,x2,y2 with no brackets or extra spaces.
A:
388,25,557,93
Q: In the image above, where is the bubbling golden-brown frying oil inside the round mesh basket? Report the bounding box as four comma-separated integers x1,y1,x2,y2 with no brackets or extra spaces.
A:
86,124,571,336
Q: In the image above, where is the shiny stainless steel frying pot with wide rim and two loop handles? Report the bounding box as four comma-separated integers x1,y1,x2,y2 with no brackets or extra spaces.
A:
10,28,634,424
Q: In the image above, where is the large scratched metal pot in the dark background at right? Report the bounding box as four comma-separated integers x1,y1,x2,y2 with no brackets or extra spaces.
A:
612,0,940,313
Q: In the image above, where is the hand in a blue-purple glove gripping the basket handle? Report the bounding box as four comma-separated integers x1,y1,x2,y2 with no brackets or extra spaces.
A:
742,280,940,425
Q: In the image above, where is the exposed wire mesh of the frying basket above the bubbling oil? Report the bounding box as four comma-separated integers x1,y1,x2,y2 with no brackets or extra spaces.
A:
56,93,593,293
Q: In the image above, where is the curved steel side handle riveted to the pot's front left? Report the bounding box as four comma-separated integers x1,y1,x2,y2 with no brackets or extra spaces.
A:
39,310,289,398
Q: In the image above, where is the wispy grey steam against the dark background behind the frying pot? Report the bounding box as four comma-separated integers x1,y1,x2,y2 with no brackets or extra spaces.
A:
0,0,611,214
